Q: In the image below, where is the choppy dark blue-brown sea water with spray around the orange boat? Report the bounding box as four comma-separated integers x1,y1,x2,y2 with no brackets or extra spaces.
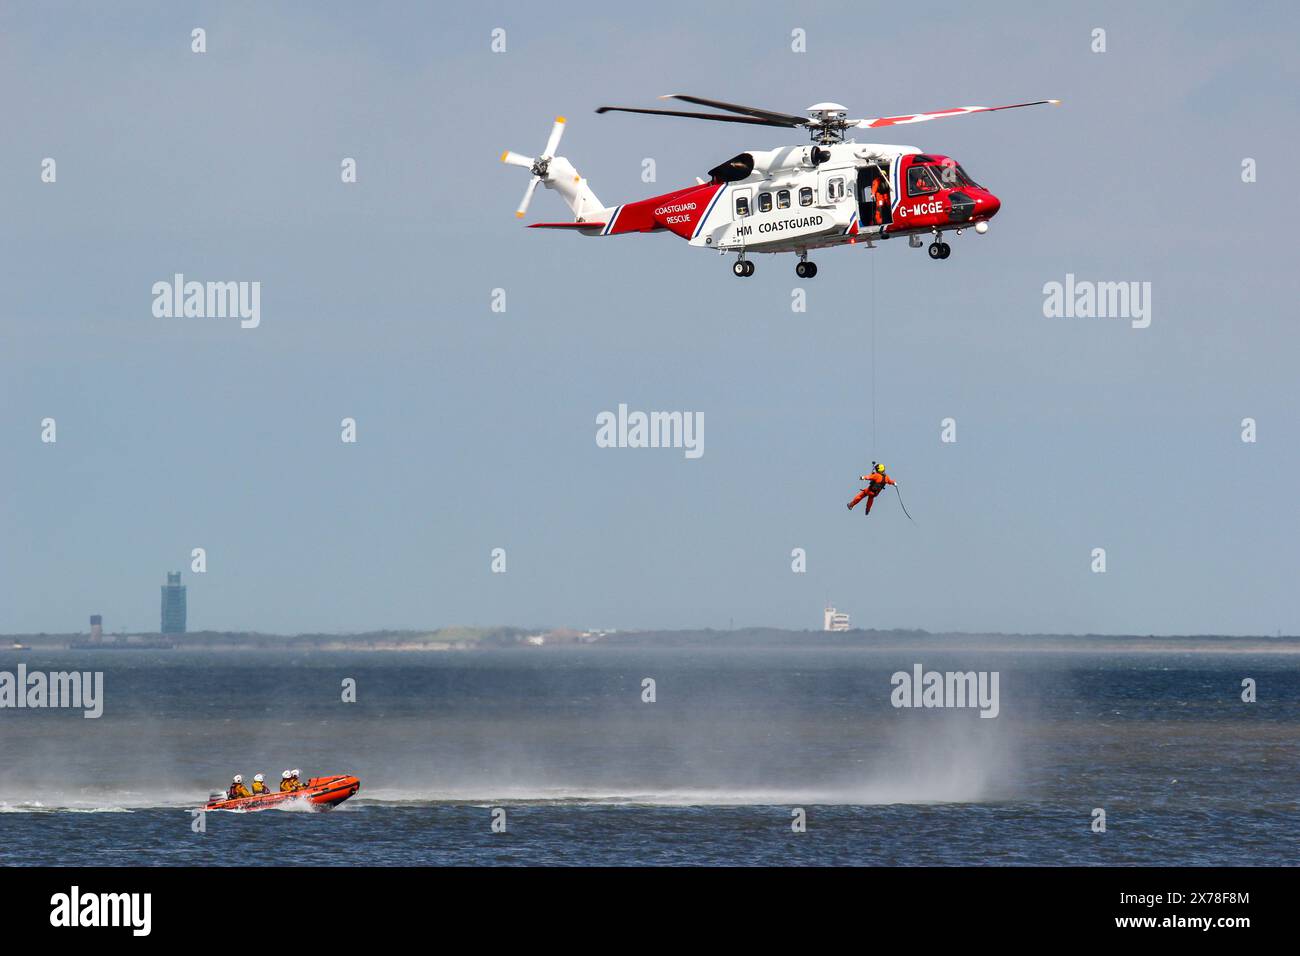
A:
0,643,1300,865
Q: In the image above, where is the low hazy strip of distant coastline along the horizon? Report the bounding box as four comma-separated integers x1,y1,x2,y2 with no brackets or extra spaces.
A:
0,627,1300,653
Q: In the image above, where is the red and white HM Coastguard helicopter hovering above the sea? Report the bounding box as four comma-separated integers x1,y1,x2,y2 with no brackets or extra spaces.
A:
501,94,1061,278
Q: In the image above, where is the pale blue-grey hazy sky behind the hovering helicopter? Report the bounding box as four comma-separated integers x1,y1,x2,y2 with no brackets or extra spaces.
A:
0,3,1300,633
